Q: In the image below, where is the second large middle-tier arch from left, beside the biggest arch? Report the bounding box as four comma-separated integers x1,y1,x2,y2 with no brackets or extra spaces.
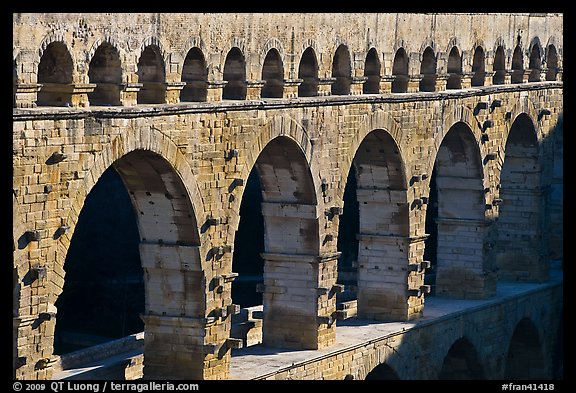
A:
233,136,326,349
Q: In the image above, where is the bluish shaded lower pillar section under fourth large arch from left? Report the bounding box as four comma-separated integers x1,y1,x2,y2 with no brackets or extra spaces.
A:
436,217,496,299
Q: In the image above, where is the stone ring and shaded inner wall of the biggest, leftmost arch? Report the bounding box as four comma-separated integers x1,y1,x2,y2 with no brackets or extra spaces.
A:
54,128,206,379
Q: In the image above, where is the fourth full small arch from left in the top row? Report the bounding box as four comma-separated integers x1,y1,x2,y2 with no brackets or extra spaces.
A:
180,47,208,102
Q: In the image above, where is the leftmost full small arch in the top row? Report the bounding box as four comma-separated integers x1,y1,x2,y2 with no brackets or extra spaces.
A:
36,41,74,106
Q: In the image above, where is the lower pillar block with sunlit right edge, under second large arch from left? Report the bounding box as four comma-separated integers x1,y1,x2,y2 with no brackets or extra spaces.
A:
262,253,340,349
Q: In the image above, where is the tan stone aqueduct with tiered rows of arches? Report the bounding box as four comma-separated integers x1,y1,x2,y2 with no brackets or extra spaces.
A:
13,14,563,379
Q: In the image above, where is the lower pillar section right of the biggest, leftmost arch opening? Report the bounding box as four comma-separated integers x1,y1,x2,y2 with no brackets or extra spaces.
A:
140,243,224,379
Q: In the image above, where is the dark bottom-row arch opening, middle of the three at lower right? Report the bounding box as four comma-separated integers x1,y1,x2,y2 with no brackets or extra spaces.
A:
438,337,485,380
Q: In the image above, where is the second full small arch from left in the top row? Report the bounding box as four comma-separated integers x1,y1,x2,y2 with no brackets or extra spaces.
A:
88,42,122,105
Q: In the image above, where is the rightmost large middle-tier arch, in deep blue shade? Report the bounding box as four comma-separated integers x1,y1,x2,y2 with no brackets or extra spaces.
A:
497,113,548,281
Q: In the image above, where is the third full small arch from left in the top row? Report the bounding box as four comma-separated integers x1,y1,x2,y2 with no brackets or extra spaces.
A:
136,44,166,104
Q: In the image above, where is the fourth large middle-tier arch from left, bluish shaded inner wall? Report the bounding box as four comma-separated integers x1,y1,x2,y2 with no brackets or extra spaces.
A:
426,122,495,298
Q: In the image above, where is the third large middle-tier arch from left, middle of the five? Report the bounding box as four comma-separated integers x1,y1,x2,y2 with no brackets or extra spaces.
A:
339,129,414,321
